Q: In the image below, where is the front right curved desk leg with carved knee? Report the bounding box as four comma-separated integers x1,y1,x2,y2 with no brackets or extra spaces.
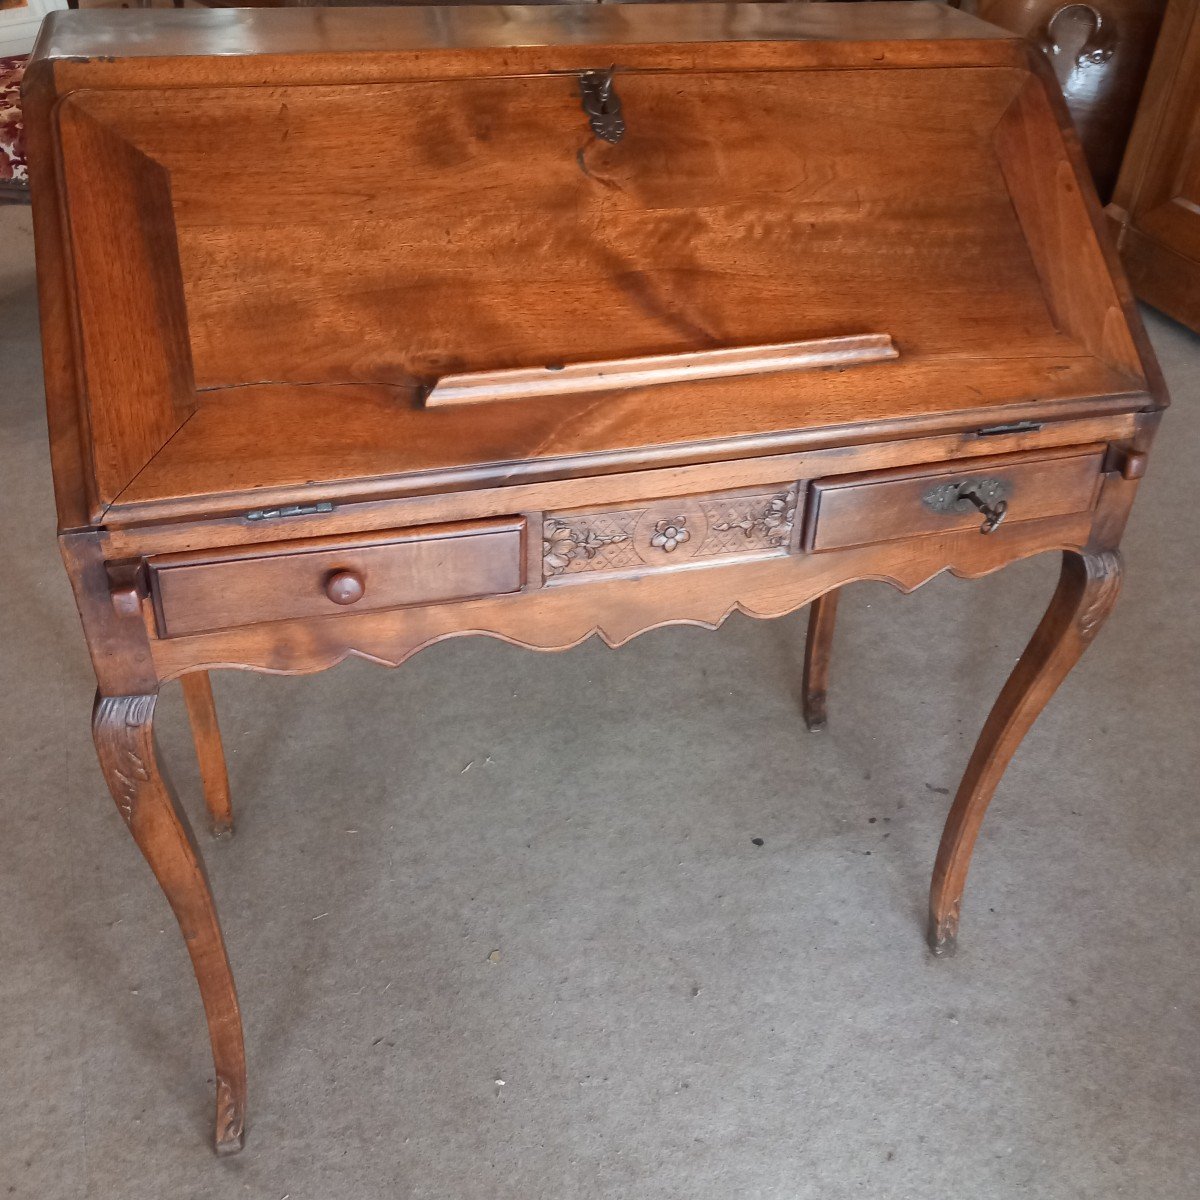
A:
929,551,1121,955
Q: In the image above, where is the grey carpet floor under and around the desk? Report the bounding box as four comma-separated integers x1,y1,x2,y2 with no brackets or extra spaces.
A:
0,201,1200,1200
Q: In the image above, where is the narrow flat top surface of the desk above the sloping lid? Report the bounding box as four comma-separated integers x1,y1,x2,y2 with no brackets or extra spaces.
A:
31,0,1015,66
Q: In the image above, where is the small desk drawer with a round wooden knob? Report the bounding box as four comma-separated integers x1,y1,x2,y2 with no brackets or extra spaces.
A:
149,517,524,637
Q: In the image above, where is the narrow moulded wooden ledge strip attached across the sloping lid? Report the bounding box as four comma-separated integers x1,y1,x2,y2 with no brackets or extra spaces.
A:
425,334,900,408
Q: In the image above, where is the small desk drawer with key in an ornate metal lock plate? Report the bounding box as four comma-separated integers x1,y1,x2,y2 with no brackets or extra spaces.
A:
804,445,1104,551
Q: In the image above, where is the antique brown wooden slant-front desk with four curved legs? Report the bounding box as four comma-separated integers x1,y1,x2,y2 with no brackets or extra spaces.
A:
28,4,1166,1151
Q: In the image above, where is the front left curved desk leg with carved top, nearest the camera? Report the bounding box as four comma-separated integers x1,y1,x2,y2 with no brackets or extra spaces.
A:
92,695,246,1154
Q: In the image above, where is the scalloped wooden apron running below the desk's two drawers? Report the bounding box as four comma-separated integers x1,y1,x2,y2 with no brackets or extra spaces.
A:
142,511,1104,679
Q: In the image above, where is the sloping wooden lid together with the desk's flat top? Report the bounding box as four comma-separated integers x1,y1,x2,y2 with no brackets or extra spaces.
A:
23,5,1157,520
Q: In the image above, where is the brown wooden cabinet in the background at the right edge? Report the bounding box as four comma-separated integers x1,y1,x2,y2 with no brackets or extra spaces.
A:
1108,0,1200,332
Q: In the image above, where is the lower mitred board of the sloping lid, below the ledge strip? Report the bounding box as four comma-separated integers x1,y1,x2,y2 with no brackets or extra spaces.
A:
106,355,1150,513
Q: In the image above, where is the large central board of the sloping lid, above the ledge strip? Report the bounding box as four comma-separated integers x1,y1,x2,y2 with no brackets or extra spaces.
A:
60,64,1054,389
